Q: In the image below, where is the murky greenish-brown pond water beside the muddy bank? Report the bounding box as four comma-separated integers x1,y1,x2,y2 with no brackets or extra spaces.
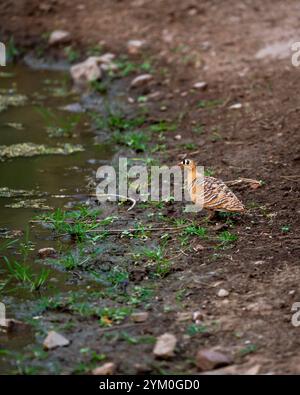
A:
0,65,123,373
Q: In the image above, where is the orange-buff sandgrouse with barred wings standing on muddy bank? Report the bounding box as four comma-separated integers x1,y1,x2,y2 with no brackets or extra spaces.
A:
179,159,245,219
